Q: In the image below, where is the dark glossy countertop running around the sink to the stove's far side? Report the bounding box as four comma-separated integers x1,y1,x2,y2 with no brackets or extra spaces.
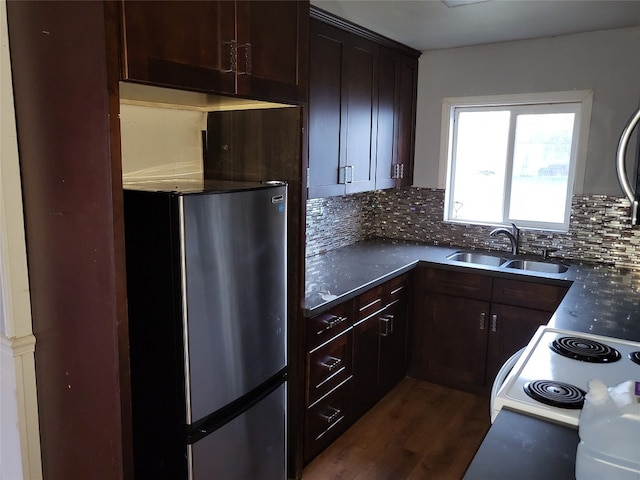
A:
305,240,640,341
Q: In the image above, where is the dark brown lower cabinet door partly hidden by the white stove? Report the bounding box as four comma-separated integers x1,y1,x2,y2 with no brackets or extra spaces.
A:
487,303,552,386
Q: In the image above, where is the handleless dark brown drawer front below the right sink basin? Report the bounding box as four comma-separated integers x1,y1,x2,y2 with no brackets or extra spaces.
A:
492,278,567,312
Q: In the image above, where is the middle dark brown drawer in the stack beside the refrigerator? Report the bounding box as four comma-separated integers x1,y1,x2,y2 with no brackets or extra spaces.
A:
306,330,353,405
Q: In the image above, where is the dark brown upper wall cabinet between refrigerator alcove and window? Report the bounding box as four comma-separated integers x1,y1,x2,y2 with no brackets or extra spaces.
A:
307,8,419,198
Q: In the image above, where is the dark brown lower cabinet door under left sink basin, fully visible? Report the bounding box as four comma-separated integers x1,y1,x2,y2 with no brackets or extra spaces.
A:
414,293,489,387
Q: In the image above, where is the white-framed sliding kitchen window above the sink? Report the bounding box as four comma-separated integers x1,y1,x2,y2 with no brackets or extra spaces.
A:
443,92,592,231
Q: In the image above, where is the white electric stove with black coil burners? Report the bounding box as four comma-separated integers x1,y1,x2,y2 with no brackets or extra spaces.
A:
491,326,640,426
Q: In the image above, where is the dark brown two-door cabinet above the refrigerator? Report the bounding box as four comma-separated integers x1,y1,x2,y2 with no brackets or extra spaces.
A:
122,1,309,103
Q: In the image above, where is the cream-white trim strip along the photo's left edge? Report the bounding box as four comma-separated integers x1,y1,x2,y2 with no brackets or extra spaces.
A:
0,0,42,480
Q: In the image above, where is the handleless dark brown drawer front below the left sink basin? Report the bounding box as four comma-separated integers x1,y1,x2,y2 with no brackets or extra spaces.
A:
424,268,492,300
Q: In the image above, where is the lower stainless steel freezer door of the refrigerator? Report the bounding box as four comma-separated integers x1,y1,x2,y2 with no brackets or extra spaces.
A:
189,383,287,480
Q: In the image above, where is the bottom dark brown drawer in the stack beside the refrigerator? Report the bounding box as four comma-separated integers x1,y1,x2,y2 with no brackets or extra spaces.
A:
304,379,351,461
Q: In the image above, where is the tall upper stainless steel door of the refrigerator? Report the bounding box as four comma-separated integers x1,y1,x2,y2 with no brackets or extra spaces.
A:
181,186,286,422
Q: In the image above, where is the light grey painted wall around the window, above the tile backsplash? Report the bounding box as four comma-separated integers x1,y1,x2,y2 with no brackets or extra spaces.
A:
414,27,640,195
